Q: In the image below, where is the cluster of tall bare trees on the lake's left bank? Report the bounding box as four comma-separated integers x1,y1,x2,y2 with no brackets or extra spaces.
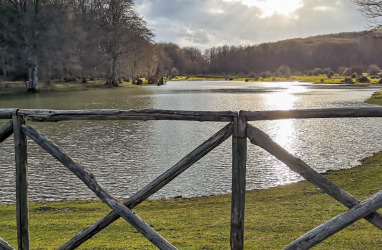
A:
0,0,153,89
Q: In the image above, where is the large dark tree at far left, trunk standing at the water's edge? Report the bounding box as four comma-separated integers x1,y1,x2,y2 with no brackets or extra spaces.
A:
0,0,78,90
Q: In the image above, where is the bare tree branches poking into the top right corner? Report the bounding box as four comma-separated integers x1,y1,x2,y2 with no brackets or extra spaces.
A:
352,0,382,29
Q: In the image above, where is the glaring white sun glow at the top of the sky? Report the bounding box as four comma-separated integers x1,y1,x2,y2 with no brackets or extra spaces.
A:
240,0,303,18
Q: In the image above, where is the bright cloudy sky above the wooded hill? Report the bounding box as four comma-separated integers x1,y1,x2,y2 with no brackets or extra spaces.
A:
134,0,367,50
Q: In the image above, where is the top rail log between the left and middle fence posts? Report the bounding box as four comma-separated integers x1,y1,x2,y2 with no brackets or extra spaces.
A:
19,109,237,122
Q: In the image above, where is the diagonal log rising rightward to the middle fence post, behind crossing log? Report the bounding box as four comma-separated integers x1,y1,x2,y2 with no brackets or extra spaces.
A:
59,123,233,250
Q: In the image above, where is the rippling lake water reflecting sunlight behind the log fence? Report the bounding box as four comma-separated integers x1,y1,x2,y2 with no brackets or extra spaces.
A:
0,81,382,204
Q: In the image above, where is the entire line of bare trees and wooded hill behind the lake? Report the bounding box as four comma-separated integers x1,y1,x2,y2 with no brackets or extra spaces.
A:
0,0,382,89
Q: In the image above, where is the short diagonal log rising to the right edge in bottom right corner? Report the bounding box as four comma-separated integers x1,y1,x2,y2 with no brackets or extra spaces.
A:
284,191,382,250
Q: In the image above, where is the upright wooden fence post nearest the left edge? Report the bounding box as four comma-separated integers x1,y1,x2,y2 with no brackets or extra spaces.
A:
12,111,29,250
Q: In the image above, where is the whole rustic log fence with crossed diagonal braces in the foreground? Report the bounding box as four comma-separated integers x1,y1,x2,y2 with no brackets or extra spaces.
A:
0,107,382,249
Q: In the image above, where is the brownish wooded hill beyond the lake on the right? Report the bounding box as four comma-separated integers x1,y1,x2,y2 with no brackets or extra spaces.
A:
201,31,382,74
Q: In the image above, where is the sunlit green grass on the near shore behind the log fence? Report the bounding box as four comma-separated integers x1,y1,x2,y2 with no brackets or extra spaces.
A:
0,152,382,249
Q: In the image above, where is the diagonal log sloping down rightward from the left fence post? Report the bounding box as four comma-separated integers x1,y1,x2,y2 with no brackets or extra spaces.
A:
22,125,176,249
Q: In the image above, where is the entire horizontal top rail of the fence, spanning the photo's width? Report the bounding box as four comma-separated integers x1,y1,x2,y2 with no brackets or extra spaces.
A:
0,107,382,122
